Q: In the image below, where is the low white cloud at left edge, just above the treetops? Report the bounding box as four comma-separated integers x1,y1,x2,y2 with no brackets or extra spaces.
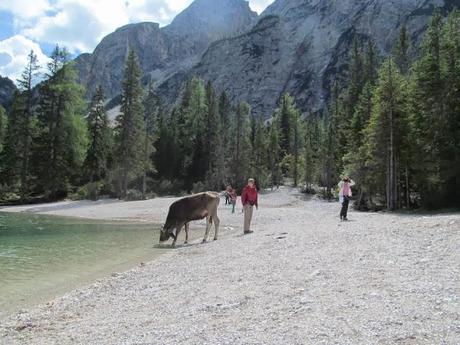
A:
0,35,50,82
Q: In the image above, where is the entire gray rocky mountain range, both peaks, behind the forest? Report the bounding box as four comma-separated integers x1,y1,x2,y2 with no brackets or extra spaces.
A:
76,0,460,117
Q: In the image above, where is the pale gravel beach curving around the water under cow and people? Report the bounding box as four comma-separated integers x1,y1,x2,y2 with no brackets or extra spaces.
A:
0,188,460,345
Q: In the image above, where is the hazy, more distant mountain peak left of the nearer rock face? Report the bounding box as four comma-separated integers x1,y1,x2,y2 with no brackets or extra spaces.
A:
76,0,257,98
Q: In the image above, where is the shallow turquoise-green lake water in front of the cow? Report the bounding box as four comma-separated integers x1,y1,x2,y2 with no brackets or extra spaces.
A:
0,213,162,316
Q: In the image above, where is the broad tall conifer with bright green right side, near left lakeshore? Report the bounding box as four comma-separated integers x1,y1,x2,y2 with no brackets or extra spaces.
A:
33,46,88,198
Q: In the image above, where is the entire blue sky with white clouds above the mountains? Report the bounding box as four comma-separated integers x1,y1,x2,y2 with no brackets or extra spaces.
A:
0,0,273,81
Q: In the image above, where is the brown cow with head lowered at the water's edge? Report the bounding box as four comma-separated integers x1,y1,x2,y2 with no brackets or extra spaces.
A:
160,192,220,247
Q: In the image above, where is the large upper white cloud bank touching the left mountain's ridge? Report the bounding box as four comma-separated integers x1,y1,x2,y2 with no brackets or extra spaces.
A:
22,0,197,52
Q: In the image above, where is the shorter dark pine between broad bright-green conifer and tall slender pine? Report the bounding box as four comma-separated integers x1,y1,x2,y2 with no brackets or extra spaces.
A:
84,86,112,182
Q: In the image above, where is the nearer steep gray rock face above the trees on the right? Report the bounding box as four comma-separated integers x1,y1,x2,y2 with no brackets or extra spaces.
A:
161,0,460,117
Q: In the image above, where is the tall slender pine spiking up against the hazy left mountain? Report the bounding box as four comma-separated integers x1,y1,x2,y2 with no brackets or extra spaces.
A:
116,50,145,199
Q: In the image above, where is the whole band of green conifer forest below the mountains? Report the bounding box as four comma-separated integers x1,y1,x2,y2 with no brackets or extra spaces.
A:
0,11,460,210
